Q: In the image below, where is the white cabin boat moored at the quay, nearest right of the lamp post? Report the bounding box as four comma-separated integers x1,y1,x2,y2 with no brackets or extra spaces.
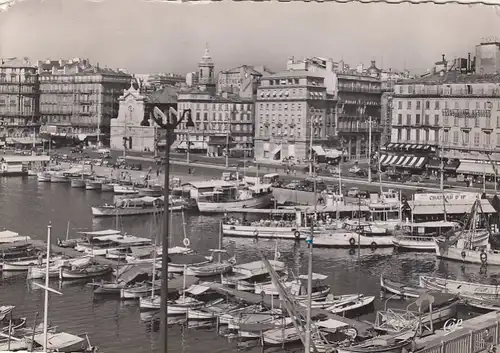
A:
196,184,273,213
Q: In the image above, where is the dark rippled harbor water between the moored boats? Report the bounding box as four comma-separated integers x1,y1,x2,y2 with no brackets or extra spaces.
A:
0,178,497,353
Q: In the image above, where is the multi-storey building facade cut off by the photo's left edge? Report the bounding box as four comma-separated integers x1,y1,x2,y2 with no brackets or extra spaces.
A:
0,58,40,145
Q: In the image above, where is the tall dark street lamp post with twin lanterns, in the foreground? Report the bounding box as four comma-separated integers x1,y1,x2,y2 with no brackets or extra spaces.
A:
153,107,194,353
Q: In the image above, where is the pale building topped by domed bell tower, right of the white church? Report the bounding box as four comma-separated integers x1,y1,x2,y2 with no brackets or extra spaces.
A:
172,48,254,156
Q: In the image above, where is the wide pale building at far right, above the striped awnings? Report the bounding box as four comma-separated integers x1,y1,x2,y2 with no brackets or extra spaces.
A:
391,71,500,166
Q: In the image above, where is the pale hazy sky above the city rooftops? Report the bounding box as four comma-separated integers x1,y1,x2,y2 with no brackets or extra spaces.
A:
0,0,500,73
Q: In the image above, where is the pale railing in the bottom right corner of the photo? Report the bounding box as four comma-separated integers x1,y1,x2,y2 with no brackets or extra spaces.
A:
417,312,500,353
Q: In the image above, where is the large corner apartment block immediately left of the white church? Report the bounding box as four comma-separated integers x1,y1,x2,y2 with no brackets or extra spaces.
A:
38,59,131,143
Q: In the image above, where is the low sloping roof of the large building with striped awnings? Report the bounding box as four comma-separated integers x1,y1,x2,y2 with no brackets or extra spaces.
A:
401,71,500,85
